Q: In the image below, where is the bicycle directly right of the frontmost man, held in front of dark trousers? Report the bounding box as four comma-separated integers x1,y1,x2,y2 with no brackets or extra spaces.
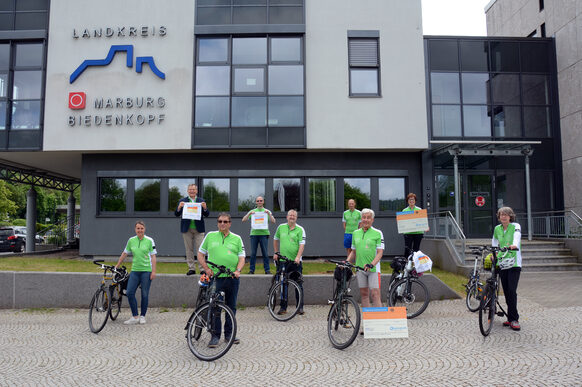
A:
267,252,303,321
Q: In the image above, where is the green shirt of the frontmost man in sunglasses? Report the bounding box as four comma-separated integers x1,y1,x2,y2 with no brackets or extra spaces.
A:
199,231,245,277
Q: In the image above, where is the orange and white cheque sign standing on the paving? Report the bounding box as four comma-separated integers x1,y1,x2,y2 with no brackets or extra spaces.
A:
362,306,408,339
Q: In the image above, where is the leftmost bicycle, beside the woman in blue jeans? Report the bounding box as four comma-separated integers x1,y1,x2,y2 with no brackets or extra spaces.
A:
89,260,129,333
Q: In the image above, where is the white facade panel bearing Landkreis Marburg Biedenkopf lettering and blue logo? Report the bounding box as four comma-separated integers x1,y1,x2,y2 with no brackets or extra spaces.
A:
43,0,194,151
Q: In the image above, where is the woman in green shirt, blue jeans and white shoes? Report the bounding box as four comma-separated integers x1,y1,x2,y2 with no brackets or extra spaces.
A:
115,220,157,325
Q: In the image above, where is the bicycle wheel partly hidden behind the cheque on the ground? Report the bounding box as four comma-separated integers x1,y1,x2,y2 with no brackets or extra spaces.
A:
388,278,430,319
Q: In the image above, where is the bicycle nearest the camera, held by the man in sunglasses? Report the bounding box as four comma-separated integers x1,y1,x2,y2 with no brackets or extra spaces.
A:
184,261,237,361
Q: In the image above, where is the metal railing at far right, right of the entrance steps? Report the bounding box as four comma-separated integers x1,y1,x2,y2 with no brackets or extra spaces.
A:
516,210,582,238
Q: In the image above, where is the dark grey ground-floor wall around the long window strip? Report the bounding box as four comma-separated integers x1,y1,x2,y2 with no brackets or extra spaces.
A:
80,152,422,257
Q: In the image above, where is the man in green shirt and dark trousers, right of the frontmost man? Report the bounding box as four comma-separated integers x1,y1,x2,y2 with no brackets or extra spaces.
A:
273,210,306,315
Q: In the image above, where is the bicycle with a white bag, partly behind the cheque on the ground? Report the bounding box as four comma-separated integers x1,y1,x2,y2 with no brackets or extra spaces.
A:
386,253,430,319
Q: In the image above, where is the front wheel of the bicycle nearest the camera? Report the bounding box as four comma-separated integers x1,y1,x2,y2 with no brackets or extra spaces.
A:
186,303,236,361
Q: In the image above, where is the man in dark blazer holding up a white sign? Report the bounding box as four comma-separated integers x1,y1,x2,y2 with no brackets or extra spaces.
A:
174,184,210,275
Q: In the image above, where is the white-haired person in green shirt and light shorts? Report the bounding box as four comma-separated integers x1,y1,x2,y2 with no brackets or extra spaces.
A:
348,208,384,308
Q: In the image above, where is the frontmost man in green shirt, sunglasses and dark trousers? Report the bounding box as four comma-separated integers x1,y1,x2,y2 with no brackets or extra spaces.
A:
198,212,245,348
